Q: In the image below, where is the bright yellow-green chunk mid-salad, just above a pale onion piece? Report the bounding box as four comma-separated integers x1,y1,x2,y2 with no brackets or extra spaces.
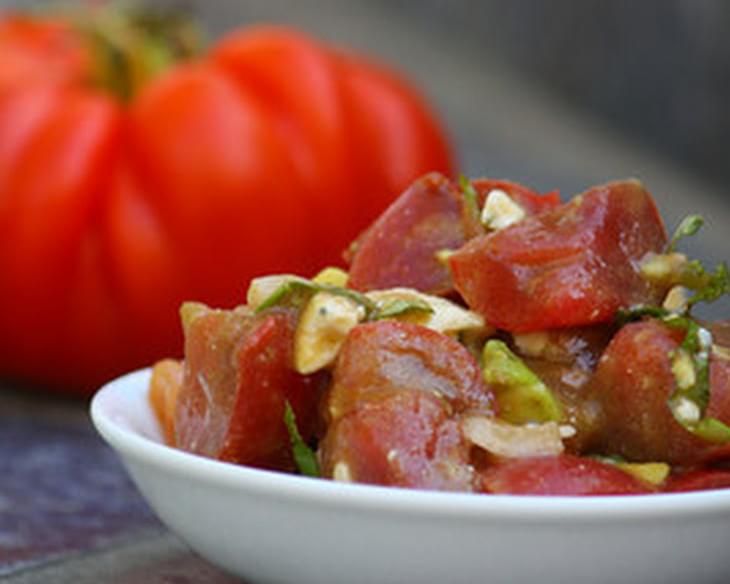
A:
482,339,563,424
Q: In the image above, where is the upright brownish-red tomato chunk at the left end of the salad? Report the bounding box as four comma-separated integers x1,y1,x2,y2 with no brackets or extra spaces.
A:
175,309,319,469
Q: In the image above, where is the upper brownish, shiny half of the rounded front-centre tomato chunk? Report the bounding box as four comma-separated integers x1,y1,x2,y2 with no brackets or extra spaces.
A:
328,320,493,419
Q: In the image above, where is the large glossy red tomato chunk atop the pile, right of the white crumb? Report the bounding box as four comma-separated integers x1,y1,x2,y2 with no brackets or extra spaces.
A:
449,181,667,332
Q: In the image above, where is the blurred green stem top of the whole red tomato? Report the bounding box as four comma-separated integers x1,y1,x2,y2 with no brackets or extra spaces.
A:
67,4,202,102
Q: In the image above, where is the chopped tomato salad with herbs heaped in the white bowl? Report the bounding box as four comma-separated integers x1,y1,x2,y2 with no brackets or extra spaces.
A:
150,174,730,495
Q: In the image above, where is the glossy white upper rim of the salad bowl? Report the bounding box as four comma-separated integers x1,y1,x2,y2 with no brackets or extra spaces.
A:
90,368,730,523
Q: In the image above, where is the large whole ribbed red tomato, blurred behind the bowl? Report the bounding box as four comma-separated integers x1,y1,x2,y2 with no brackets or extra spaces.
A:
0,9,451,394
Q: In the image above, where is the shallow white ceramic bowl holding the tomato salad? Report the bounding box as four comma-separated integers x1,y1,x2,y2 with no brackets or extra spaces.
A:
91,370,730,584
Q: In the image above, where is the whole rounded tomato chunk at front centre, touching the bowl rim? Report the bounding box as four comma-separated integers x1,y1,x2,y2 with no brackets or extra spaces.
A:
321,321,493,491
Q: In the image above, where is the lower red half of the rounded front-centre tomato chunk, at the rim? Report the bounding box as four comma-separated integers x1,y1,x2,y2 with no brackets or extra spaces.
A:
321,390,473,491
